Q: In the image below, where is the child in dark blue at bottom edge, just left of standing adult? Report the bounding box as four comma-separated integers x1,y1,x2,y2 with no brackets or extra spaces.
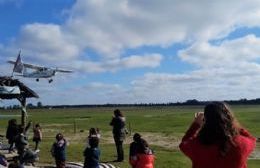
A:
84,137,100,168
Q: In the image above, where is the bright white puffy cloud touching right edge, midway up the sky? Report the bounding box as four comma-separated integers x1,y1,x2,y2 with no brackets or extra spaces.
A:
178,35,260,68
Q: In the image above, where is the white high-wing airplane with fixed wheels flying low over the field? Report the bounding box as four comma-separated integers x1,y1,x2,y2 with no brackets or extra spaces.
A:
8,51,73,83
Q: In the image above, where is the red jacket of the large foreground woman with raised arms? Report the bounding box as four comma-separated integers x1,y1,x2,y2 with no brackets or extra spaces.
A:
179,123,256,168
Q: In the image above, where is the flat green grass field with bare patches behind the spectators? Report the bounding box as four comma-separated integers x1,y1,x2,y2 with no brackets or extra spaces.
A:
0,105,260,168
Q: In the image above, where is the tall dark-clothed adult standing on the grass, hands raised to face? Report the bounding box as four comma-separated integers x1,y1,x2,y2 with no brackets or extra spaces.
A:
110,109,126,162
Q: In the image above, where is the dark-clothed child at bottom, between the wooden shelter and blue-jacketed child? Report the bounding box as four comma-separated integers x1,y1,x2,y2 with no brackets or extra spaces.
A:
51,133,67,168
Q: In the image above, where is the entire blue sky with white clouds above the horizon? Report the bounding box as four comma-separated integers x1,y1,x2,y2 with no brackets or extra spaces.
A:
0,0,260,105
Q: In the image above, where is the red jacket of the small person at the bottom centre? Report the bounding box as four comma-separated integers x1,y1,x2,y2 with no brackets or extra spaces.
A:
129,154,155,168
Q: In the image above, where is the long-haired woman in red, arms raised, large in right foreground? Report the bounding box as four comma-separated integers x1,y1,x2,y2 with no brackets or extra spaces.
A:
179,102,256,168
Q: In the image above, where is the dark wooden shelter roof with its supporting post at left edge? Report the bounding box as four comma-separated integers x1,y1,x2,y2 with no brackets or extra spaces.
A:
0,76,39,126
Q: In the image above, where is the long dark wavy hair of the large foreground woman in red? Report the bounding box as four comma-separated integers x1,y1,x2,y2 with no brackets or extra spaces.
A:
198,102,239,156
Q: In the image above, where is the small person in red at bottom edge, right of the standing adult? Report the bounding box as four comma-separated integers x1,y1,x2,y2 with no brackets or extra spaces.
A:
129,138,155,168
